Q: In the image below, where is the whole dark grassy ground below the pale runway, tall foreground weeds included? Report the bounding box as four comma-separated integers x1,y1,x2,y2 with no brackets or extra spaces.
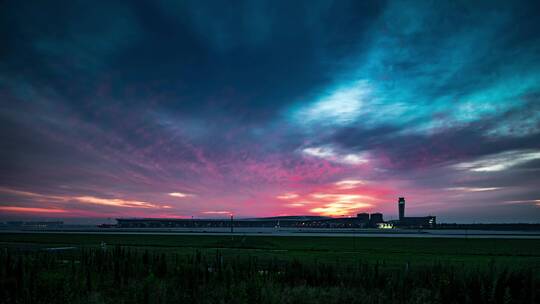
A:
0,235,540,304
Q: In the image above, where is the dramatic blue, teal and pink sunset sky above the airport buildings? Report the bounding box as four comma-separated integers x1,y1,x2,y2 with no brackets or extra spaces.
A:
0,0,540,223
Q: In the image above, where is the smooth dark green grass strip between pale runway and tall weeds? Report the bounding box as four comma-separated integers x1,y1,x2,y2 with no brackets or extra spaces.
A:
0,233,540,269
